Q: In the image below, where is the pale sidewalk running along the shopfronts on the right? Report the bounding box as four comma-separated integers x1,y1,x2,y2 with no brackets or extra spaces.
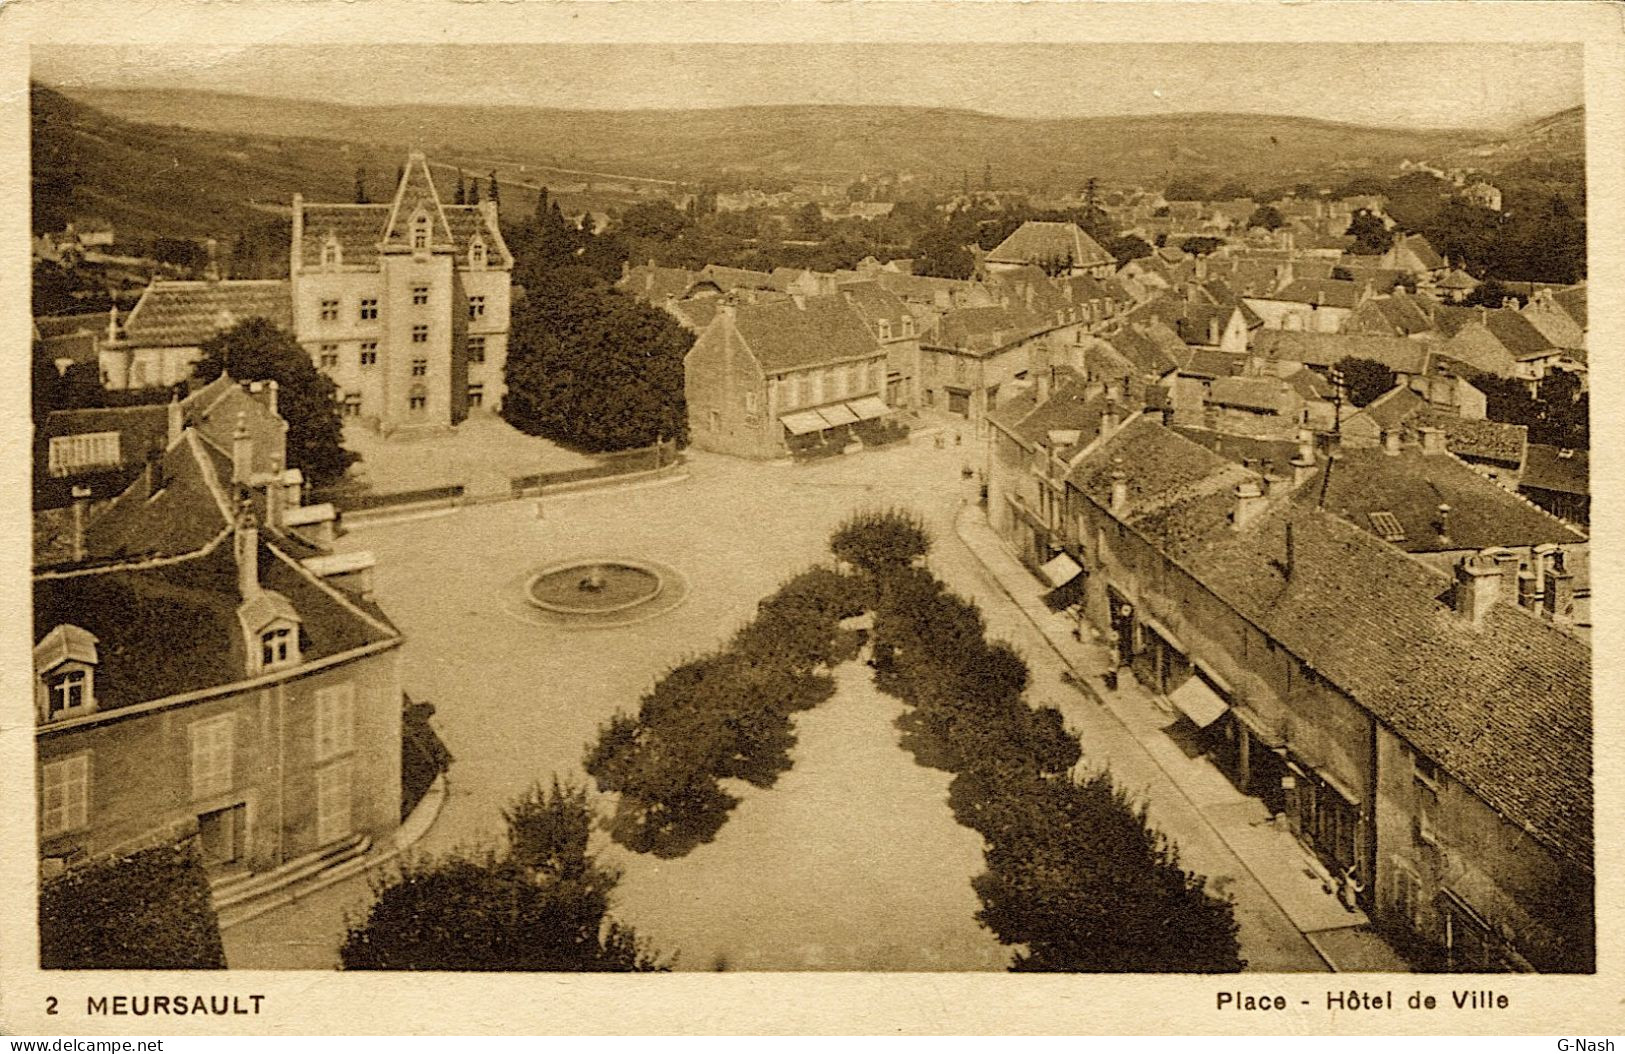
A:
954,503,1409,973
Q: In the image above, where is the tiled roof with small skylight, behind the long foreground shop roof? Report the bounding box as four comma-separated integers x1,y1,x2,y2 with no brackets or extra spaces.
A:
1294,447,1586,552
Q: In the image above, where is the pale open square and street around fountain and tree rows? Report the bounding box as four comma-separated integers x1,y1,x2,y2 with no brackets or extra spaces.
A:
226,429,1326,970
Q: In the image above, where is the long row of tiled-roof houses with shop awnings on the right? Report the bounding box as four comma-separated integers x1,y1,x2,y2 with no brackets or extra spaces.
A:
988,367,1594,971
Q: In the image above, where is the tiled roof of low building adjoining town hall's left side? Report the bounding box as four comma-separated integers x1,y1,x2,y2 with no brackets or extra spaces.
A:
124,281,293,348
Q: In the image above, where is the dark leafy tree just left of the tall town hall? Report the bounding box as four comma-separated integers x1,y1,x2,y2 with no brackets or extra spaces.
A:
192,318,358,484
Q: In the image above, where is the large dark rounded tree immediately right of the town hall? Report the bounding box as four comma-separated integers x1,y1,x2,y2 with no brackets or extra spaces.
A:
502,268,694,451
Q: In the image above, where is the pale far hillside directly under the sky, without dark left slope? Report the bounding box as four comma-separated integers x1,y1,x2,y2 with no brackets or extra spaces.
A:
63,89,1508,185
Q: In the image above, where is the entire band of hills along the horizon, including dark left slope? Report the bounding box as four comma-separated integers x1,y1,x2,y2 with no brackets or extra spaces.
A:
34,86,1584,245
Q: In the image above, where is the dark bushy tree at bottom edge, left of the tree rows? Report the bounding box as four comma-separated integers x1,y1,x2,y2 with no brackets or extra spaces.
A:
340,780,666,973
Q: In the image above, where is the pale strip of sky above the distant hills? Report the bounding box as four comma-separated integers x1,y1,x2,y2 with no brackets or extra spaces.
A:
33,42,1584,128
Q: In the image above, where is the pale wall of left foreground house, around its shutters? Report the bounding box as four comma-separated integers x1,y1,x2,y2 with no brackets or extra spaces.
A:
37,648,401,870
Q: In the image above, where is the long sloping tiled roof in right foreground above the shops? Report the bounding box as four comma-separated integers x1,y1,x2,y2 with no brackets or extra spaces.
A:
1188,500,1593,867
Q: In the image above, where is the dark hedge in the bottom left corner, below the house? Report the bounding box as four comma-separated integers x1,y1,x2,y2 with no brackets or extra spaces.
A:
39,840,226,970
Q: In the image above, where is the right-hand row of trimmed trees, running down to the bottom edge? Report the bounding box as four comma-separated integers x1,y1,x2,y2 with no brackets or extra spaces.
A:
835,513,1243,973
